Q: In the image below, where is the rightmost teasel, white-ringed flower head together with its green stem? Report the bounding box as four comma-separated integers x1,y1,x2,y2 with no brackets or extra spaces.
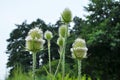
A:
71,38,88,80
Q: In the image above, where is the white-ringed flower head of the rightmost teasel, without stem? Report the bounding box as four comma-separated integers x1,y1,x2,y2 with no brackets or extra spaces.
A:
71,38,88,59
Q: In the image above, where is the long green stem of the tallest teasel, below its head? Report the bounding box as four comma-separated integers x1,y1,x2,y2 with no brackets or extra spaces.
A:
62,24,68,80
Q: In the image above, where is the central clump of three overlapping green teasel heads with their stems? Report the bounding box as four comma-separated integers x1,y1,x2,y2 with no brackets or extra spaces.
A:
55,8,72,80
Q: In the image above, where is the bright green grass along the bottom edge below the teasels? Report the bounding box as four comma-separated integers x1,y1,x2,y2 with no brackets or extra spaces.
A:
6,66,95,80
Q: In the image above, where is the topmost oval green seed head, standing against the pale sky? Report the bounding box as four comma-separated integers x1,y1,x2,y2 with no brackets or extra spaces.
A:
61,8,72,23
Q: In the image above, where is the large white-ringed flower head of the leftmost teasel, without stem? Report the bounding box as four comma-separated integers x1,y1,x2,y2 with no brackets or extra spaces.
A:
25,27,45,52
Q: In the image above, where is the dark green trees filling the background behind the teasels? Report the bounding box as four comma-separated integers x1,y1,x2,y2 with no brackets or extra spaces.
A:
6,0,120,80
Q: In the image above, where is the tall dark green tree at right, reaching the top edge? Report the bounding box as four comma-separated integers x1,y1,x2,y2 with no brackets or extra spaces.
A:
81,0,120,80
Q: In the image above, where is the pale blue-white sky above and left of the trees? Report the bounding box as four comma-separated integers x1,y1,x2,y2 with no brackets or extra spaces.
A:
0,0,89,80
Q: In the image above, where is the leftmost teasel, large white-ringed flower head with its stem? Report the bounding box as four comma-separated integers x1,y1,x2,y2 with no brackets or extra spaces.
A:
25,27,45,80
